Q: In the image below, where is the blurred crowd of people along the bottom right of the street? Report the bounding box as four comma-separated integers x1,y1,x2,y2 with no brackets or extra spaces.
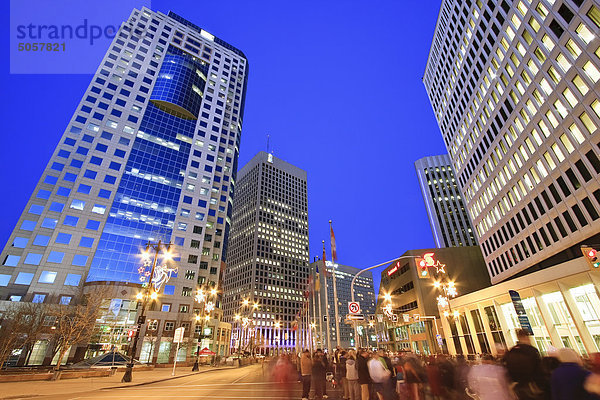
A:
273,330,600,400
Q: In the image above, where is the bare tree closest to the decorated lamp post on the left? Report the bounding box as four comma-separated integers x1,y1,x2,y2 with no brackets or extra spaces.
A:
49,288,107,379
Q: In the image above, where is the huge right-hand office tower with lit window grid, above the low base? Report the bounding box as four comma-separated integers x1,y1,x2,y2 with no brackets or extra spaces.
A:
424,0,600,283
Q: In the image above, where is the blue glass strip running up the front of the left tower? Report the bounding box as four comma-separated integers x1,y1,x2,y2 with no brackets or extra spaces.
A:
87,48,204,283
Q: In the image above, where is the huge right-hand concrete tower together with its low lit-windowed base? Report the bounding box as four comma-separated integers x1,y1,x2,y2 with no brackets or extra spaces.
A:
424,0,600,355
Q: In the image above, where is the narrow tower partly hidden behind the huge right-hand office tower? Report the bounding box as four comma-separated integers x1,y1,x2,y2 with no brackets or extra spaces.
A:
415,154,477,247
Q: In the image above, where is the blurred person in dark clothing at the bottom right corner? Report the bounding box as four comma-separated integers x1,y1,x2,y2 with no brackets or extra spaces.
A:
550,348,599,400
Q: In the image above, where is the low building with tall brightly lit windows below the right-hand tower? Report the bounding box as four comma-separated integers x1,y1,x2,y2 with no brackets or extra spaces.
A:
442,258,600,356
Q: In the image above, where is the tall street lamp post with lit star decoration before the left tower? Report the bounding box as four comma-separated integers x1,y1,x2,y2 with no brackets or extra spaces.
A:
121,240,171,382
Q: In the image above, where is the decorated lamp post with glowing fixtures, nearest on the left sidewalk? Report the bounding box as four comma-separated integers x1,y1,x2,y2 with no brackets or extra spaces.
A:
121,240,177,382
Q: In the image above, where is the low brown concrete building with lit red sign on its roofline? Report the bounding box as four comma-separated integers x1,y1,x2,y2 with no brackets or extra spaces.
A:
375,246,490,354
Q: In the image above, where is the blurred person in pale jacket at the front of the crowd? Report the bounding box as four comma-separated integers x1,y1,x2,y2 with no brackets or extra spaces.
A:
467,354,515,400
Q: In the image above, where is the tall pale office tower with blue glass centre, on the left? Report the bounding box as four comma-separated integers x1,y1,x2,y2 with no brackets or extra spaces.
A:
0,8,248,360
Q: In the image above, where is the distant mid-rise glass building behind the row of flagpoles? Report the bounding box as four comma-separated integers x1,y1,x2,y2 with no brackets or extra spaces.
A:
309,258,375,349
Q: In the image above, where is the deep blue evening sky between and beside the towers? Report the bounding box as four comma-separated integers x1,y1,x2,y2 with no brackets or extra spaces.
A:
0,0,446,296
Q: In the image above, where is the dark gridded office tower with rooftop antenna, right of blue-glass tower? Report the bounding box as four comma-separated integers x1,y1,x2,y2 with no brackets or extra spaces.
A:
223,151,308,351
